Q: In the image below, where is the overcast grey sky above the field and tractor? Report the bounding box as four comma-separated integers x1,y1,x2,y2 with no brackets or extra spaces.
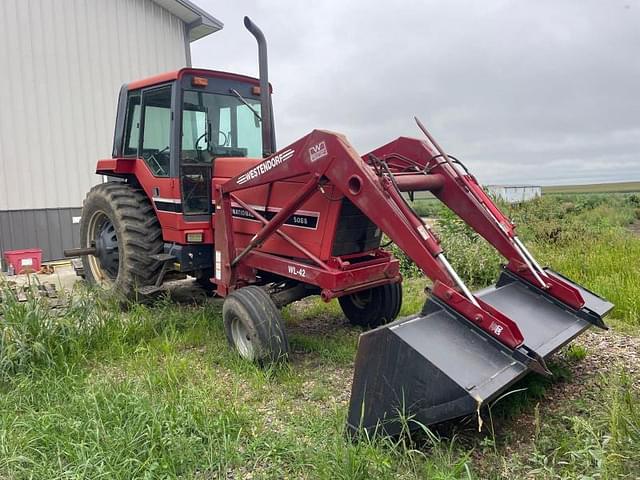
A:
192,0,640,184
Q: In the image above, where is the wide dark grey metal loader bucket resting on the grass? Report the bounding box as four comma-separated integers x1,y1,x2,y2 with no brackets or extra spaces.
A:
347,270,613,435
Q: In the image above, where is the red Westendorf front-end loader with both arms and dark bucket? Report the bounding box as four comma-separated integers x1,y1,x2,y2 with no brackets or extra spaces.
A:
215,124,613,434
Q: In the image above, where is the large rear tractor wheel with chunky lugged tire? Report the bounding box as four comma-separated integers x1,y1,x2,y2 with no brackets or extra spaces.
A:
80,182,164,300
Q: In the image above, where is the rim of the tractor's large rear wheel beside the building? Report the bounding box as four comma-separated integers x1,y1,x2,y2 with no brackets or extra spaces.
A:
86,211,120,286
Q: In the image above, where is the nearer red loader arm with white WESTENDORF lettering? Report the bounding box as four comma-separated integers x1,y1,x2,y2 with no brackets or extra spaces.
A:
215,130,545,350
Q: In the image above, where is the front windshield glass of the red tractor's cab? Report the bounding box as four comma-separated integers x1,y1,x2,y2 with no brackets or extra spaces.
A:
180,90,262,162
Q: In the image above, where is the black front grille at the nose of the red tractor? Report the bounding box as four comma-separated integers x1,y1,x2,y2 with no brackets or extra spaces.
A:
332,198,382,257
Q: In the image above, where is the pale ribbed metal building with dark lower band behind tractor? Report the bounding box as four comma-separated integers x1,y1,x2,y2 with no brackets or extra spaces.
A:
0,0,222,260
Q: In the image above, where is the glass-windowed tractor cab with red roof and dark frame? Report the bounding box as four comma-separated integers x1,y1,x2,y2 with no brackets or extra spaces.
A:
113,68,275,215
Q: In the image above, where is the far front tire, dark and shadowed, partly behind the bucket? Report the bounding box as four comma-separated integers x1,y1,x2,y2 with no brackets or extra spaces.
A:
338,283,402,328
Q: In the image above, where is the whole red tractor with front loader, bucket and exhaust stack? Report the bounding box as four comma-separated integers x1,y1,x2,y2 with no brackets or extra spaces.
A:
68,18,612,433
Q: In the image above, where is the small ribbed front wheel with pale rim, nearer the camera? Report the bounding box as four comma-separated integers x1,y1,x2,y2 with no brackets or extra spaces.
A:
222,285,289,365
